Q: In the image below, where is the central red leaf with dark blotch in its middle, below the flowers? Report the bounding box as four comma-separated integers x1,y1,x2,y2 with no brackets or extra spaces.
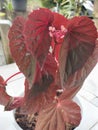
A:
18,53,60,113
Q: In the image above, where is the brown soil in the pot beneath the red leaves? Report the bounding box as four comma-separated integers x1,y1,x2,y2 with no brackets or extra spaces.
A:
15,108,75,130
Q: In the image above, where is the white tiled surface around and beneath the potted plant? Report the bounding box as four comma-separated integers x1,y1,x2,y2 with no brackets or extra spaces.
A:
0,63,98,130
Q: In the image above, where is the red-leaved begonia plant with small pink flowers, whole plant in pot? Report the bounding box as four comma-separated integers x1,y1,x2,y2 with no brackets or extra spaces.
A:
0,8,98,130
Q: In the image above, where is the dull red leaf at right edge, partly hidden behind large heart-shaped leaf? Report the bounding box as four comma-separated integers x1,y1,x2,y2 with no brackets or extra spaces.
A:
59,40,98,89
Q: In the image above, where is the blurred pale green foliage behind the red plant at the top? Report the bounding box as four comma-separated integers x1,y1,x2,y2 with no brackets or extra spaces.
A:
41,0,92,18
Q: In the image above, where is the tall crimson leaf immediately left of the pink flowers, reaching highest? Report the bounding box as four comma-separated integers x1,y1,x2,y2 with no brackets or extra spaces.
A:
24,8,53,65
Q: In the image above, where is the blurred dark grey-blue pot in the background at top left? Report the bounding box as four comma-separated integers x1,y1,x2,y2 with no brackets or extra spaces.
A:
12,0,27,12
